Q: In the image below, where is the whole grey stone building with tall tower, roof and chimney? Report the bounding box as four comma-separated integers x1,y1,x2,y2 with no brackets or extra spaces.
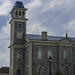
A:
9,1,75,75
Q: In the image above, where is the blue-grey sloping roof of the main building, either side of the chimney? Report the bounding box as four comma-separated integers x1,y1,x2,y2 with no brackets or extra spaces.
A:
26,34,75,41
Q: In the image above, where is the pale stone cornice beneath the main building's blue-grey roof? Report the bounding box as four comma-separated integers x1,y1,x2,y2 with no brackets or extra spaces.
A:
26,40,75,46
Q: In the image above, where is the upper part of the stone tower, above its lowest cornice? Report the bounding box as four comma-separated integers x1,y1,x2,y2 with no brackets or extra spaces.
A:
10,1,27,44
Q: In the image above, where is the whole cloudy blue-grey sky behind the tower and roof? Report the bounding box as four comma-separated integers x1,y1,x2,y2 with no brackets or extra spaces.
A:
0,0,75,67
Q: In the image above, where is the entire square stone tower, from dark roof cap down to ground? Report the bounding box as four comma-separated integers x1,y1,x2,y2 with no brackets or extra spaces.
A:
9,1,28,75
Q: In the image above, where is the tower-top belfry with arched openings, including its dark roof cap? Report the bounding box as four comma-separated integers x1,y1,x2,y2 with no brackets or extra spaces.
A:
10,1,27,19
